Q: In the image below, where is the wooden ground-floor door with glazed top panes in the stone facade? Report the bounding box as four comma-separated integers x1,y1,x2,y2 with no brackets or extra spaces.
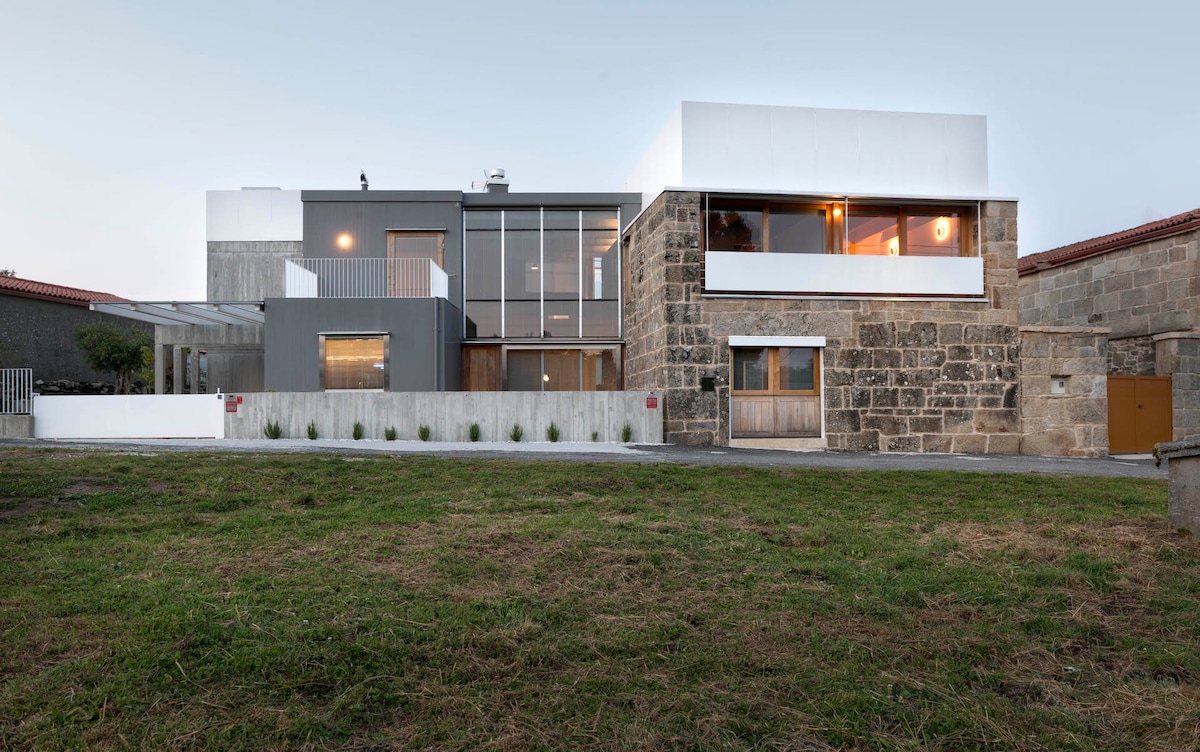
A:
730,348,821,439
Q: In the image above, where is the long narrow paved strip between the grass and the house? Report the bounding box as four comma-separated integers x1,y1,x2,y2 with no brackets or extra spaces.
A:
0,439,1166,480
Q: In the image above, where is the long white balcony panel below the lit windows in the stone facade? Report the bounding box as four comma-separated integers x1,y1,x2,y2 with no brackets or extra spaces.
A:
704,251,983,296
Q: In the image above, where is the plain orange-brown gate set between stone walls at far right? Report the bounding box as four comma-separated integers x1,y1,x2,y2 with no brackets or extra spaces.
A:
1109,375,1171,455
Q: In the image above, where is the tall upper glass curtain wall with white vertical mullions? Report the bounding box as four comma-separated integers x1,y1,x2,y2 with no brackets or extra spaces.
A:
464,209,620,338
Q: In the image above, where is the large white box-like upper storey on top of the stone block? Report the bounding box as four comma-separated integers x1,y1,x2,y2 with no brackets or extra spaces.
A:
625,102,988,206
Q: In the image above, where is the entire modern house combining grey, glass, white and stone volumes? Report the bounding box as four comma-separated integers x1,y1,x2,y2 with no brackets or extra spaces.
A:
97,102,1041,453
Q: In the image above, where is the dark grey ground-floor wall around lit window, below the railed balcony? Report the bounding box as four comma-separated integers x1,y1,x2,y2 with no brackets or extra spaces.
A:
264,297,462,392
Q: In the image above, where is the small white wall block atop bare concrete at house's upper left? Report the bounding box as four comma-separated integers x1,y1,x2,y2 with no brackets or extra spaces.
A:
208,188,304,242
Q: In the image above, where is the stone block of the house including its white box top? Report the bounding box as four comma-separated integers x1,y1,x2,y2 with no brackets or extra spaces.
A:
622,103,1021,453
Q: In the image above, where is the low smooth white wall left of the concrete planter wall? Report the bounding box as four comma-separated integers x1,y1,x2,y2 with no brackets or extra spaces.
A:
34,395,226,439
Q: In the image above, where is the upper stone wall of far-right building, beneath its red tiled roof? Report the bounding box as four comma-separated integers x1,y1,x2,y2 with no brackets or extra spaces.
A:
1020,231,1200,339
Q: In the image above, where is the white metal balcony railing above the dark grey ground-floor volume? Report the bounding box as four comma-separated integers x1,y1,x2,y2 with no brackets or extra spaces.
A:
284,259,450,297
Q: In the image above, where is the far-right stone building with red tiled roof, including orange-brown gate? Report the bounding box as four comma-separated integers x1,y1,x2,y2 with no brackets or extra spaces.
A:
1018,210,1200,453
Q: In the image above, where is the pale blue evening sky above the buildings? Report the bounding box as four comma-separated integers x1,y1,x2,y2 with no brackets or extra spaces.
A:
0,0,1200,301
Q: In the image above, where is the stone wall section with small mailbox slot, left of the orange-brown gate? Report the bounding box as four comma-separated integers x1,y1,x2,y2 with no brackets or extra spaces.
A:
1021,326,1109,457
